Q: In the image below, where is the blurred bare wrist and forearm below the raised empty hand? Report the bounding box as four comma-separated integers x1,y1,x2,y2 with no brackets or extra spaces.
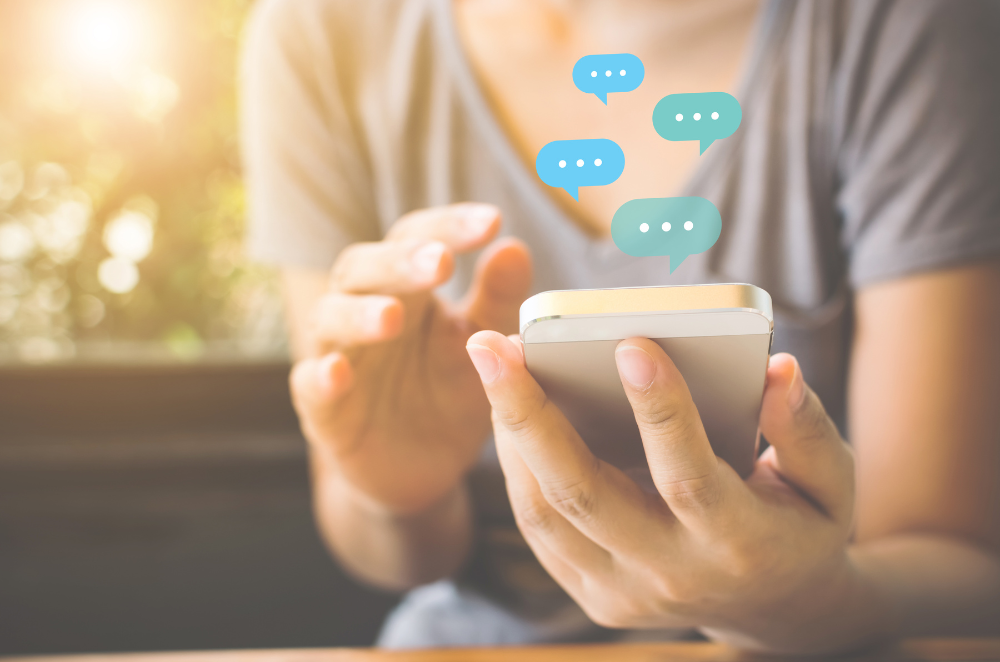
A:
313,448,472,590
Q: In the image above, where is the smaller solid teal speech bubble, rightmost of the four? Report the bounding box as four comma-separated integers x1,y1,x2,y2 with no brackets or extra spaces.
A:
653,92,743,154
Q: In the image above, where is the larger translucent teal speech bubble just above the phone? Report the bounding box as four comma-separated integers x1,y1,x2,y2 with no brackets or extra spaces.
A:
611,196,722,273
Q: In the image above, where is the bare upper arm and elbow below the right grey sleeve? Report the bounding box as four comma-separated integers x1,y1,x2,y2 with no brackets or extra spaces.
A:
849,263,1000,636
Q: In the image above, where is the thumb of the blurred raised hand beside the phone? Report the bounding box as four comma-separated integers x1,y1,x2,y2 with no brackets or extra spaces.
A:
465,238,531,334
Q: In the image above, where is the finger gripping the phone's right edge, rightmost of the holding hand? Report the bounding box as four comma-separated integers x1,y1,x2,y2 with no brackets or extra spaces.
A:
760,354,854,521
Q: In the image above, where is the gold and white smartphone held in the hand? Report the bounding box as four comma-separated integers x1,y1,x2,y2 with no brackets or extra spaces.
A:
520,283,774,478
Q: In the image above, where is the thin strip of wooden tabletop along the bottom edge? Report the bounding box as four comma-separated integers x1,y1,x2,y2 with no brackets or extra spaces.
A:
3,639,1000,662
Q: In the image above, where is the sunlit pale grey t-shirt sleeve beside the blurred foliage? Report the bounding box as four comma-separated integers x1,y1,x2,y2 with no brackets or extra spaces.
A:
240,0,379,269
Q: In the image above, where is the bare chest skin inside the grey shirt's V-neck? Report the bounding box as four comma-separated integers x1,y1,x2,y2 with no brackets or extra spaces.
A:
456,0,757,237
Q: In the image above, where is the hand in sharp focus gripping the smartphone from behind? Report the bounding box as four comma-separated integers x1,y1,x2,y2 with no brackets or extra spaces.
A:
467,331,863,651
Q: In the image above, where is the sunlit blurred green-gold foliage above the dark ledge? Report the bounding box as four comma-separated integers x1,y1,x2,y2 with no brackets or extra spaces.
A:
0,0,284,362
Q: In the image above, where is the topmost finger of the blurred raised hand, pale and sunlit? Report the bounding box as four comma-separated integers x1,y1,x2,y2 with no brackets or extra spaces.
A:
385,202,500,251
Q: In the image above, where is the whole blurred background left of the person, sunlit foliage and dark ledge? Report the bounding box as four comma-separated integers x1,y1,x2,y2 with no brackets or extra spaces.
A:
0,0,392,655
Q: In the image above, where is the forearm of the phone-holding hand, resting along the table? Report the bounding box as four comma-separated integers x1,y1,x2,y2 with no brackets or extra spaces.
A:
704,535,1000,654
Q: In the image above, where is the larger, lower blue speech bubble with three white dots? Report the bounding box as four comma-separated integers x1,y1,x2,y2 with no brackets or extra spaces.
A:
535,138,625,200
